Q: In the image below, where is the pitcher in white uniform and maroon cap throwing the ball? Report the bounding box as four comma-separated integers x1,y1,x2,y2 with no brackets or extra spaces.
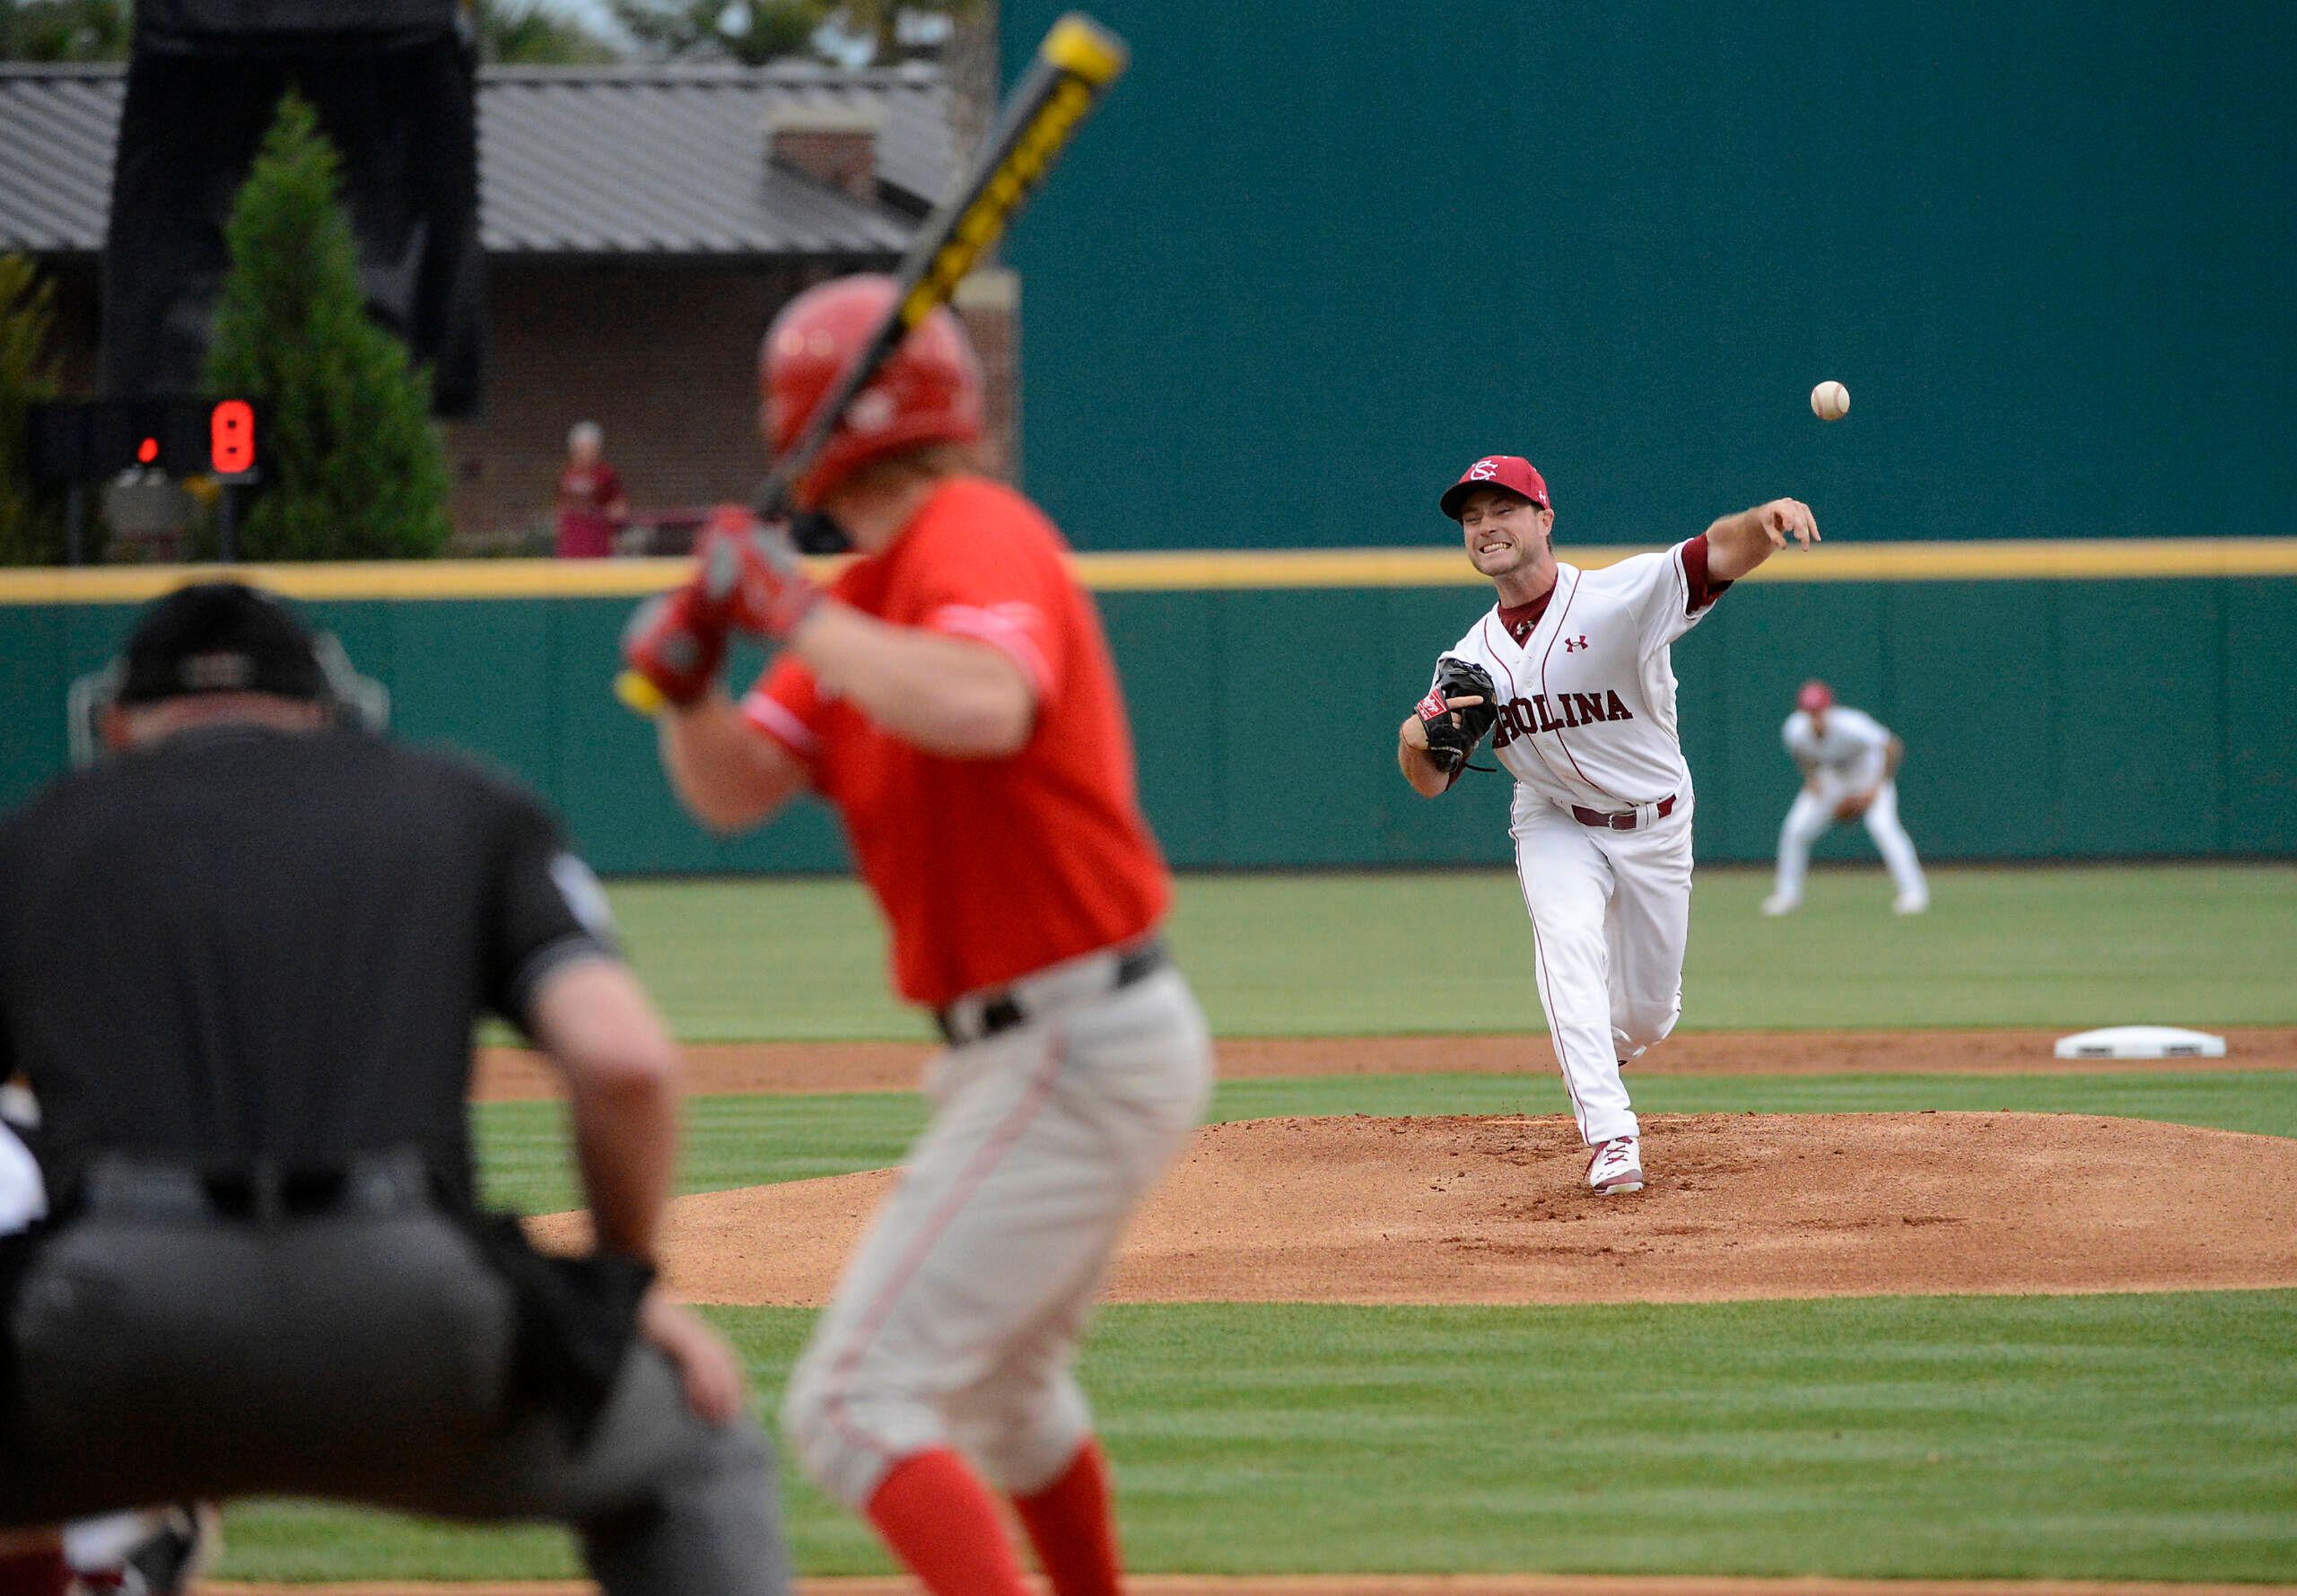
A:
1396,455,1820,1194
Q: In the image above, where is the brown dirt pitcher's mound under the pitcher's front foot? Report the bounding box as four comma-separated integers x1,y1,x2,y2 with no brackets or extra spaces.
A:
535,1113,2297,1304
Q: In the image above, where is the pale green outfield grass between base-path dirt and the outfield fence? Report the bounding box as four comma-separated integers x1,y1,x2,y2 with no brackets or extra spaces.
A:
611,868,2297,1041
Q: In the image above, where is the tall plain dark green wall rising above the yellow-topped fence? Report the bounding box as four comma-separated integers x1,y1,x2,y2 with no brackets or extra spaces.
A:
1000,0,2297,549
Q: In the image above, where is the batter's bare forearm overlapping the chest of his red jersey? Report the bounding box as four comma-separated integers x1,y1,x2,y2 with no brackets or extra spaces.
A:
790,604,1036,760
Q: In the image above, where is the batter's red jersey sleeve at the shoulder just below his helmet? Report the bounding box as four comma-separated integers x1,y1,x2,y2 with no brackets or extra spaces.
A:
903,511,1070,702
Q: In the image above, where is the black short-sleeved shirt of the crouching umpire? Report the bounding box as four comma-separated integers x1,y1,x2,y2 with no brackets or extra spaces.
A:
0,726,611,1208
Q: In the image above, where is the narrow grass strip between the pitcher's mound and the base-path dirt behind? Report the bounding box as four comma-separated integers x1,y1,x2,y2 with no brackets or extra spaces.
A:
473,1079,2297,1213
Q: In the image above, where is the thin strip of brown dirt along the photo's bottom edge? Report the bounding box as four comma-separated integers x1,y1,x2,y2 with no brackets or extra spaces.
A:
196,1573,2297,1596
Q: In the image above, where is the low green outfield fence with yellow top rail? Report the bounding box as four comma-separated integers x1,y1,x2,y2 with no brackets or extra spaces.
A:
0,540,2297,873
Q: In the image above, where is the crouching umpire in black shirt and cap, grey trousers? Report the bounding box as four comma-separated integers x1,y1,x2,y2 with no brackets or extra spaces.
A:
0,583,788,1596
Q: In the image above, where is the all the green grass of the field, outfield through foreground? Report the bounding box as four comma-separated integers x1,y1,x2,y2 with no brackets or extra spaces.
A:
221,866,2297,1583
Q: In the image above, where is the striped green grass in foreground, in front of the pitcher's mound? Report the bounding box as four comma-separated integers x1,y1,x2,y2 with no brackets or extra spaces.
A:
218,1291,2297,1583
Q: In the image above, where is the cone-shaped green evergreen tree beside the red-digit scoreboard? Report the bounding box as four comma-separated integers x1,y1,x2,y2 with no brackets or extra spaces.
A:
205,92,450,561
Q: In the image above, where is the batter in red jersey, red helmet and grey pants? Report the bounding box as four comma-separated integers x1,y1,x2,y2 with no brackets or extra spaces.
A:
624,278,1210,1596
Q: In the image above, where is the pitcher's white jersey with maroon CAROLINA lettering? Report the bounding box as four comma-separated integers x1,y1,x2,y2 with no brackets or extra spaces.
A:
1445,537,1730,813
